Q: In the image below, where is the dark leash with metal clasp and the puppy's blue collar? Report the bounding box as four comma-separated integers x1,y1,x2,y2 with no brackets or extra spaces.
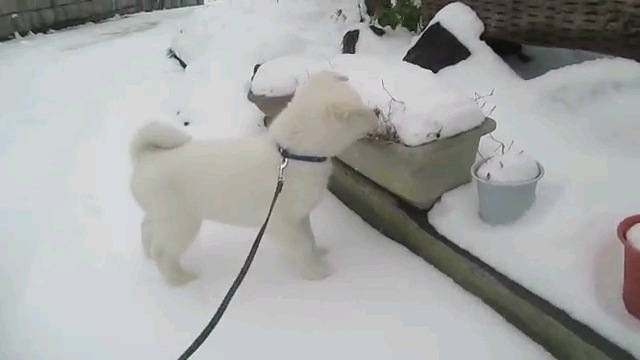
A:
178,146,327,360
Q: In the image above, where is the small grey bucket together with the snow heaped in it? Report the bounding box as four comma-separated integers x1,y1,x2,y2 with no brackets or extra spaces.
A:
471,149,544,225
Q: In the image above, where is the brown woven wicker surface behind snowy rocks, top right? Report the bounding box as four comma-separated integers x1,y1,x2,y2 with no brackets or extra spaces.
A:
422,0,640,60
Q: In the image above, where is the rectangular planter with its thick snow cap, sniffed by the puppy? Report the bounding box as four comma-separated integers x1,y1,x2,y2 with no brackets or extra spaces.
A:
248,55,496,209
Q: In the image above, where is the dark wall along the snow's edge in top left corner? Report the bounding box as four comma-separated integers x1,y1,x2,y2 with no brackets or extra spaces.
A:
0,0,204,40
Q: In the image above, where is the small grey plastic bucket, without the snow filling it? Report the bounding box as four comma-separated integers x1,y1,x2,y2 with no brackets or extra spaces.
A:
471,160,544,225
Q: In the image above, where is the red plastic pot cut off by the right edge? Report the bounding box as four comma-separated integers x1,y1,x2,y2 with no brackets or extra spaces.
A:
617,214,640,319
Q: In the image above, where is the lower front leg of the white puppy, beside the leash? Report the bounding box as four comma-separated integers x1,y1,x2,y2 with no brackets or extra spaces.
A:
269,216,331,280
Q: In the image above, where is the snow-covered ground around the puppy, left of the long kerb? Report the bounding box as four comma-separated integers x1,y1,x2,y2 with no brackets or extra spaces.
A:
0,0,550,360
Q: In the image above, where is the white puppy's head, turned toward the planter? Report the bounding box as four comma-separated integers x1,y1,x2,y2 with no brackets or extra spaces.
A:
270,71,379,156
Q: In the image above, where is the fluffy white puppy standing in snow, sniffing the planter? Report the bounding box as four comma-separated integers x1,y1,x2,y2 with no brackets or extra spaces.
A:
130,72,378,285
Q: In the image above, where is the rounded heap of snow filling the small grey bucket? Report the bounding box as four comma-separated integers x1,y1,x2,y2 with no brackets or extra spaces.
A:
476,149,540,183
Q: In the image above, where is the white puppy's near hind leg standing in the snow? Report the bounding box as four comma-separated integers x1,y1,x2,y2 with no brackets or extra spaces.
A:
152,212,202,286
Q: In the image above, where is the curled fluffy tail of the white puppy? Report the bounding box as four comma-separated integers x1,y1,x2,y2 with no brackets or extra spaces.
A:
129,121,191,163
